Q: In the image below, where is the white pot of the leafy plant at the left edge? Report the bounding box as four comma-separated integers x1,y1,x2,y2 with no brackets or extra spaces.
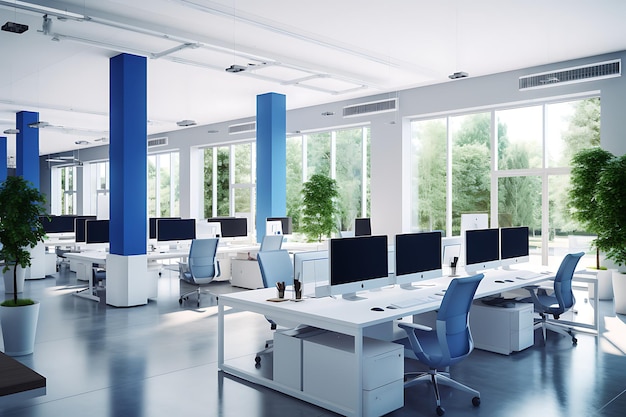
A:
0,301,39,356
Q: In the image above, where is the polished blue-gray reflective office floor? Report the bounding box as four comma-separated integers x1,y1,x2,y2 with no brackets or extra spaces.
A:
0,270,626,417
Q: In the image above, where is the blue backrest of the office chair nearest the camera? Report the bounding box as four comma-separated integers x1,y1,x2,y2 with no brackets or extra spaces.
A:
437,274,484,364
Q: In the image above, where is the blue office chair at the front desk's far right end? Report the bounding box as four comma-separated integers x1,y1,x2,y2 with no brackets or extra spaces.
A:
522,252,585,345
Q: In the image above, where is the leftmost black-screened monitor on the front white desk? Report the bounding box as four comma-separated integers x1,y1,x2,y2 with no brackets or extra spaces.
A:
328,235,390,300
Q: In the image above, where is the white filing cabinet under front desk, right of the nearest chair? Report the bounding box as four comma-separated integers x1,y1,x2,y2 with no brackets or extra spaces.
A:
470,301,534,355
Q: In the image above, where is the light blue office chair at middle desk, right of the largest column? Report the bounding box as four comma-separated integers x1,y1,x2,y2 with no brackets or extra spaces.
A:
178,238,220,307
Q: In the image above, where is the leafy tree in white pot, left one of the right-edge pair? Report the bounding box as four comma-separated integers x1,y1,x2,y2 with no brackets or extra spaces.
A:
569,147,615,300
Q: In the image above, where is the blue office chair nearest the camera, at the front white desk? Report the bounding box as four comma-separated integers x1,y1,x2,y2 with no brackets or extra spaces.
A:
398,274,484,416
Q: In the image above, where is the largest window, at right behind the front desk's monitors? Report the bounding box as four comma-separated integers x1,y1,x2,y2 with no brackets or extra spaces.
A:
411,97,600,264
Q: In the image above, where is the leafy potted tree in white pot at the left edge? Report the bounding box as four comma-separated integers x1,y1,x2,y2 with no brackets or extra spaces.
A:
0,176,46,356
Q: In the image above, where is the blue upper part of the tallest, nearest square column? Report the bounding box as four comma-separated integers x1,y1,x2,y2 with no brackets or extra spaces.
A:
109,54,148,256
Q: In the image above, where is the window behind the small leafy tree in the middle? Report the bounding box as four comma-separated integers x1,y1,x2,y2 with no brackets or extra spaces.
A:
287,126,370,232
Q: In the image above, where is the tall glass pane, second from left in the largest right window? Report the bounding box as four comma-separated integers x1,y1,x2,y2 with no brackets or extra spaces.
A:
450,113,491,235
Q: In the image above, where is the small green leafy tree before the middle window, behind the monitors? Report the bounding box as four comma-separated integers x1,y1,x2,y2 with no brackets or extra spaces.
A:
301,174,339,242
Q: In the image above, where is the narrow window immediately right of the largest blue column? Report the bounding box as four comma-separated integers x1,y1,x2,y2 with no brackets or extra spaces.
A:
148,152,180,217
